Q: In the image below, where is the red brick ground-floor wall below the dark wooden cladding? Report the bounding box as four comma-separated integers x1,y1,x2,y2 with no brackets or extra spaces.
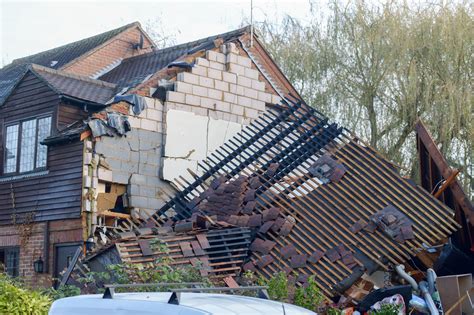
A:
0,219,82,287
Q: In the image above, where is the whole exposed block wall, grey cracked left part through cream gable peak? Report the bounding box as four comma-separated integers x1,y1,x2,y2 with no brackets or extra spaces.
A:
83,43,280,226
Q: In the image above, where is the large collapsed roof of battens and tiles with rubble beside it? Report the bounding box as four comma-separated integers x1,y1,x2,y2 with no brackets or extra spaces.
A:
65,100,472,312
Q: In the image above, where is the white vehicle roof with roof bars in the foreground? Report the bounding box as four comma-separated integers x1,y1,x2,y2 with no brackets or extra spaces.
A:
49,288,316,315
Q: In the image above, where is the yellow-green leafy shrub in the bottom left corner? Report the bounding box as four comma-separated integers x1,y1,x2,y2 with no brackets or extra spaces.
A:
0,273,51,315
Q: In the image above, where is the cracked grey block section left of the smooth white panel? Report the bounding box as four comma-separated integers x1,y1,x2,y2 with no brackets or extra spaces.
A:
85,97,169,221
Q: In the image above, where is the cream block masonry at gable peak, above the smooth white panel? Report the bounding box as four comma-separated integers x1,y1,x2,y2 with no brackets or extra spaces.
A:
166,43,279,124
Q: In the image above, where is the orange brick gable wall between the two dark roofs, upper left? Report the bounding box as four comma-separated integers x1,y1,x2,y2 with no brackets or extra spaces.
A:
61,27,151,77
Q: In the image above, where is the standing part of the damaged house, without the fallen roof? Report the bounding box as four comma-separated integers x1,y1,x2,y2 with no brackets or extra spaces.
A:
0,23,297,286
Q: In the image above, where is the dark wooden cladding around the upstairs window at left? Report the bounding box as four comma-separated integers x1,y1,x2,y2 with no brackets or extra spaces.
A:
0,73,87,225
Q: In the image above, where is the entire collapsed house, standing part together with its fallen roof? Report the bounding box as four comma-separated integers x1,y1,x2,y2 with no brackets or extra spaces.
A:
0,23,473,312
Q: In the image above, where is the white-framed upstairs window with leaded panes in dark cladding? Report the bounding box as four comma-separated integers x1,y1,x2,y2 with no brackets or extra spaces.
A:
3,117,51,174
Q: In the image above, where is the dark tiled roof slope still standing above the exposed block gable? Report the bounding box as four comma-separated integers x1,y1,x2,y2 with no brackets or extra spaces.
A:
99,27,249,87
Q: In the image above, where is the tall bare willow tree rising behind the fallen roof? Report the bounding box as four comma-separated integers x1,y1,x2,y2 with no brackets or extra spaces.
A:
260,0,474,196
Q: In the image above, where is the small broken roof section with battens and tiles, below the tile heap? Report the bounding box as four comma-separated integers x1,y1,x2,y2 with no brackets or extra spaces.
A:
115,227,251,277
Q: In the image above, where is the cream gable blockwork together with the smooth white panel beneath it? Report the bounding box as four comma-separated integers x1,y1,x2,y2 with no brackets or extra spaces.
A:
162,43,280,181
